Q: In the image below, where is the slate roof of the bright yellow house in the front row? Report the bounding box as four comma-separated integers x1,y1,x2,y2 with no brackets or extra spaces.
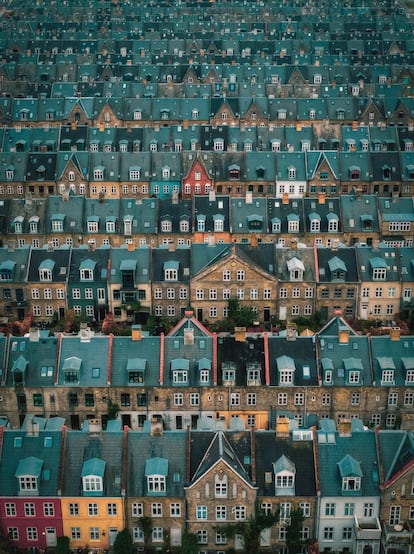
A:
62,430,123,496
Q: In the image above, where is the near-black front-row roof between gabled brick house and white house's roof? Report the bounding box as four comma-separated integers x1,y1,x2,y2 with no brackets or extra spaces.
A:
254,431,316,496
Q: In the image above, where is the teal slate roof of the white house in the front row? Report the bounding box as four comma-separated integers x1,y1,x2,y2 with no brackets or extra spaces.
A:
318,422,378,497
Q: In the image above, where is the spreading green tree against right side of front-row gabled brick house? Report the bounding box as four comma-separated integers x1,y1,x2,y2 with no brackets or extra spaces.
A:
217,505,279,554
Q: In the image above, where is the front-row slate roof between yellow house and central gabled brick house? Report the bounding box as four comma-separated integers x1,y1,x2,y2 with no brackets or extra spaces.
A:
127,431,187,497
